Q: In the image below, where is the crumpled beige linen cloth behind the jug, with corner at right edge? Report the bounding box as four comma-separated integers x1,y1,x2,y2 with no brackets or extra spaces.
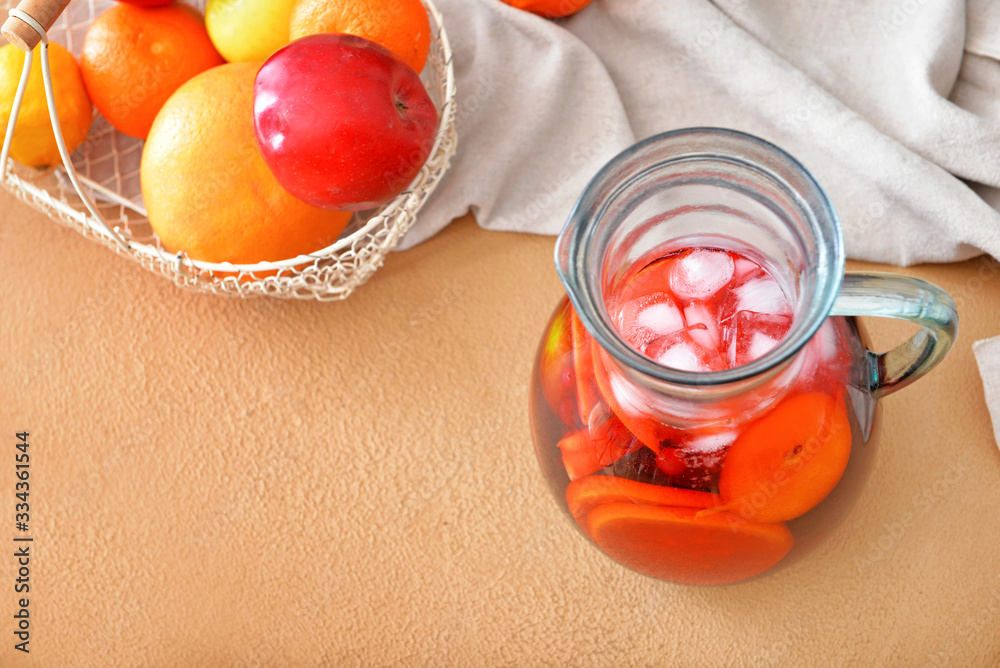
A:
402,0,1000,446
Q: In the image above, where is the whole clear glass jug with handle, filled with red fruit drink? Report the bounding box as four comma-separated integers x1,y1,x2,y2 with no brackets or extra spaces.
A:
530,128,958,584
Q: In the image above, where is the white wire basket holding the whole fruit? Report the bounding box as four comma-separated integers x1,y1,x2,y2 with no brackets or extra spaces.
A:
0,0,458,301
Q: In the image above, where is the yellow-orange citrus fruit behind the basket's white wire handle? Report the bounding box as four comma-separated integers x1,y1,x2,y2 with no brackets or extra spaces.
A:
0,42,94,167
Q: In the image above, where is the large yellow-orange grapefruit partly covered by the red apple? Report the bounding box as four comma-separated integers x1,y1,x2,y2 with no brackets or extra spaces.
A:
141,63,351,264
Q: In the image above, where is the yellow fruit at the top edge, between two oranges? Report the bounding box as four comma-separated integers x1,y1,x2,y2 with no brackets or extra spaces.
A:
205,0,295,63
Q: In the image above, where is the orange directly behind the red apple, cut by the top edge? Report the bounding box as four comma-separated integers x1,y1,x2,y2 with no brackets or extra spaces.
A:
288,0,431,72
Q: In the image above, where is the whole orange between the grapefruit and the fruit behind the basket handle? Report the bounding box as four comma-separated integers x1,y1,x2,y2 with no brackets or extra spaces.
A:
80,3,225,139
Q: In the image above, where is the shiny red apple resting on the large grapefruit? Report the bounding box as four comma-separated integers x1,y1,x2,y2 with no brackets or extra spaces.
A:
253,34,437,211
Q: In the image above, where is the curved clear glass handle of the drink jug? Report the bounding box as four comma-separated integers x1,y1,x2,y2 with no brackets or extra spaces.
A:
830,271,958,397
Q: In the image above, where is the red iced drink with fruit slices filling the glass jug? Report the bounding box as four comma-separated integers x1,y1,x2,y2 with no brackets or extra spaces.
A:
532,244,864,584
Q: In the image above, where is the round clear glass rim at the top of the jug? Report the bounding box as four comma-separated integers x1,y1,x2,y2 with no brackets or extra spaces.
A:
555,127,845,386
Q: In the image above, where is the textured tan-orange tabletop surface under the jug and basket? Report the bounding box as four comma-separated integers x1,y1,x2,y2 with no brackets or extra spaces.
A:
0,193,1000,668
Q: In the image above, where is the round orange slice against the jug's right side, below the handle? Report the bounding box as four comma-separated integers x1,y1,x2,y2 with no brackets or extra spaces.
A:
719,392,851,522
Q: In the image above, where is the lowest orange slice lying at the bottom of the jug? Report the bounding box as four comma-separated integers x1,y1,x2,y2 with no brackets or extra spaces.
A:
587,503,794,585
